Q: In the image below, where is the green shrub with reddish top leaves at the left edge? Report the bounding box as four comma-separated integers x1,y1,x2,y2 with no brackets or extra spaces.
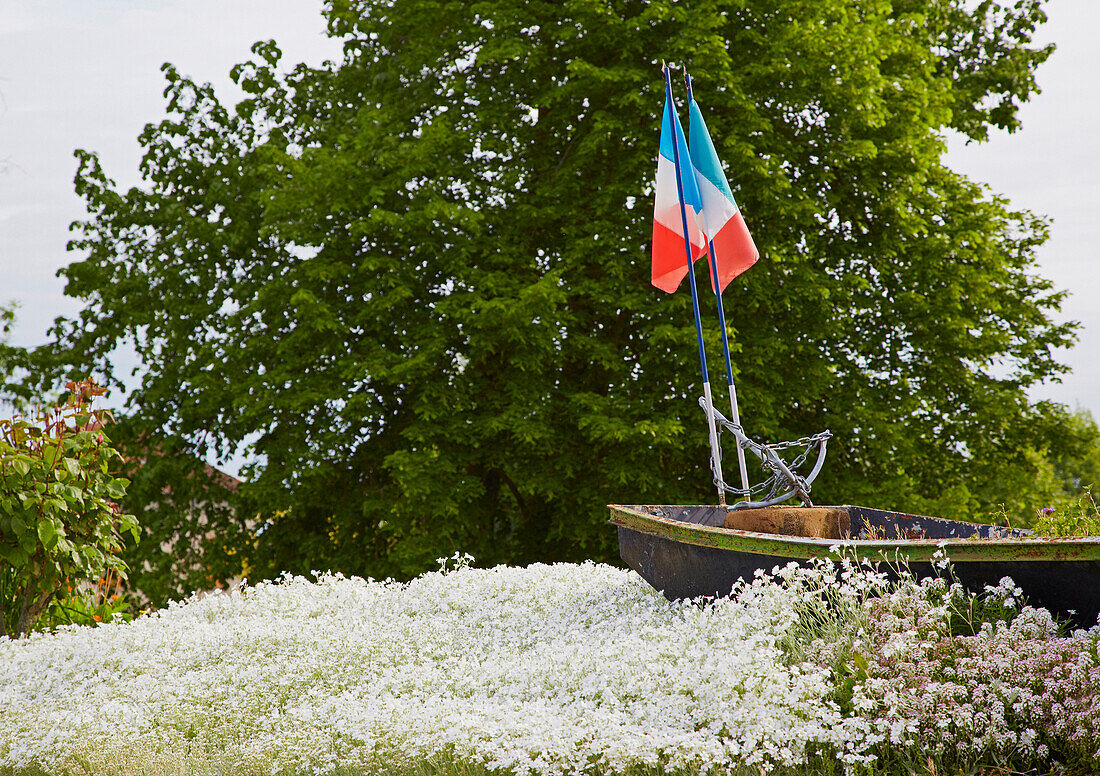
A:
0,379,138,637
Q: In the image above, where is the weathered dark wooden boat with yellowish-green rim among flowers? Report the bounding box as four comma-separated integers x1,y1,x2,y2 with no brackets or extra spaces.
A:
608,504,1100,629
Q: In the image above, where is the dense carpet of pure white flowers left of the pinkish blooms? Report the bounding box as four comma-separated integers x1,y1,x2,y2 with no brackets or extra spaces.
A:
0,556,869,774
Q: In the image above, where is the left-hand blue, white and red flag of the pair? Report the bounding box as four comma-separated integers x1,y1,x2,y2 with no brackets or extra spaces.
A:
650,91,706,294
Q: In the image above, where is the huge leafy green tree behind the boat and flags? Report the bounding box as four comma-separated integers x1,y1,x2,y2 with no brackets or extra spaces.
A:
23,0,1073,576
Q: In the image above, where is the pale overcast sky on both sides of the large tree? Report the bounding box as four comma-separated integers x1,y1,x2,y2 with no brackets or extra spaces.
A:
0,0,1100,427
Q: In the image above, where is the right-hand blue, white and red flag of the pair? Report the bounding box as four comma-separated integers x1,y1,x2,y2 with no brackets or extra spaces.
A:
686,99,760,293
